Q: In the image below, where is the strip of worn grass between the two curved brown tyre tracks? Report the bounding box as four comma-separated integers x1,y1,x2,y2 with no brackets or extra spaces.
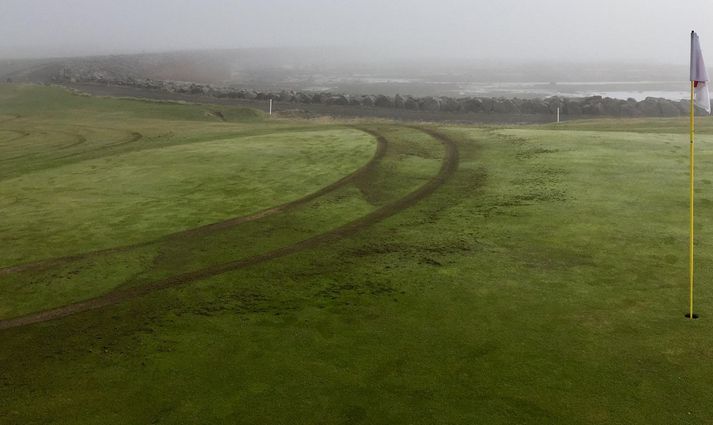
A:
0,121,443,319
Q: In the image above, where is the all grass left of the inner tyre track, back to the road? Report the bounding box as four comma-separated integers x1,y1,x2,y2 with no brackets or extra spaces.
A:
0,86,374,266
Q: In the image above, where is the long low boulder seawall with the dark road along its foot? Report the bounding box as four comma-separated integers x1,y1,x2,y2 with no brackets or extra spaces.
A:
56,78,702,123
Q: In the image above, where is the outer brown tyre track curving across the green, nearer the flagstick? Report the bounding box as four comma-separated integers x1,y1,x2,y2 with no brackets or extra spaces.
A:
0,129,459,329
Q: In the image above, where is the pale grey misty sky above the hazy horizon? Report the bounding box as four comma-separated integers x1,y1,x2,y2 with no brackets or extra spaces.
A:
0,0,713,64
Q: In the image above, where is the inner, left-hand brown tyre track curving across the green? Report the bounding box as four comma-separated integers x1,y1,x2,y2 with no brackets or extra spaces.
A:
0,127,386,276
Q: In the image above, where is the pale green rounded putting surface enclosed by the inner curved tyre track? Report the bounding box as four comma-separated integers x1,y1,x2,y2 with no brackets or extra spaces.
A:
0,129,374,265
